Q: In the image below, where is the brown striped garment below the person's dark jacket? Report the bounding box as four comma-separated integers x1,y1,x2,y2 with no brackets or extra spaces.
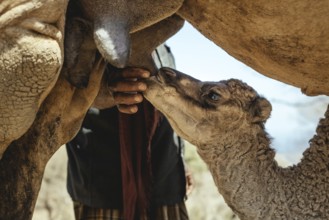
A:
74,202,189,220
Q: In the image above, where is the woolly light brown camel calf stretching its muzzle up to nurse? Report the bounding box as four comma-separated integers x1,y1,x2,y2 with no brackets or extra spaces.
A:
144,68,329,220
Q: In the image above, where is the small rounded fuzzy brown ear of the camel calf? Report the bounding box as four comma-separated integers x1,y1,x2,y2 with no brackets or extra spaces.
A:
250,97,272,123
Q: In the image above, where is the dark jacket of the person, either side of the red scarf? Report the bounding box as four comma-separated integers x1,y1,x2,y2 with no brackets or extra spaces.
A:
67,108,185,208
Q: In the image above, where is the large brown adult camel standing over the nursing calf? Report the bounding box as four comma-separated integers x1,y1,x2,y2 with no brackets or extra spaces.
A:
0,0,329,219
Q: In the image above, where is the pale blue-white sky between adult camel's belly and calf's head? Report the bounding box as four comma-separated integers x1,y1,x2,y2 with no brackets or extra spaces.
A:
167,22,329,164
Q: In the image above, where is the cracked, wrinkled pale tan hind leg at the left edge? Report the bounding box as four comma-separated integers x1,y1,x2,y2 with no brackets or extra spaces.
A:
0,0,67,158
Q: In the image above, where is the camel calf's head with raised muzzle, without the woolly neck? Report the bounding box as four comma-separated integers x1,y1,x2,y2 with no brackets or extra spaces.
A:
144,68,271,145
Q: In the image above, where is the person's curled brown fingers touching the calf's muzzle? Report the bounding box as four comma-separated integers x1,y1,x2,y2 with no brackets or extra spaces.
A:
109,68,150,114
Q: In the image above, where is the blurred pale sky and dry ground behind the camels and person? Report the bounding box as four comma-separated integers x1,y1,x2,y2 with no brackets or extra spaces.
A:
33,23,329,220
